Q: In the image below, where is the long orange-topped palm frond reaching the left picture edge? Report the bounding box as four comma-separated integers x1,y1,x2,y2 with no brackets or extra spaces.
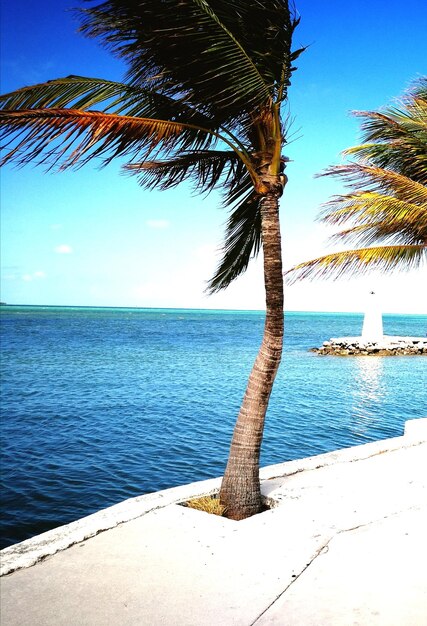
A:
0,109,212,169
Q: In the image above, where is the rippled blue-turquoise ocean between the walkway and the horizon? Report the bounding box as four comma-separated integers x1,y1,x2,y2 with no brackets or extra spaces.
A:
1,306,427,547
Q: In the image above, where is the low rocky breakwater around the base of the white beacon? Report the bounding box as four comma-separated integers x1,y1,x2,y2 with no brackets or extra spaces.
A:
311,336,427,356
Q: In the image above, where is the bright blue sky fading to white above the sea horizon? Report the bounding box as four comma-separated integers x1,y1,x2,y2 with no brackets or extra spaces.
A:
1,0,427,313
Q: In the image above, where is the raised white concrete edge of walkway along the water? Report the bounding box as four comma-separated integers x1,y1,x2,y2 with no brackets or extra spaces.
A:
0,418,427,576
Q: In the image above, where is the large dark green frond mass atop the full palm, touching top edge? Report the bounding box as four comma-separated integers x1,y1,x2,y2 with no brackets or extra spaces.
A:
80,0,296,120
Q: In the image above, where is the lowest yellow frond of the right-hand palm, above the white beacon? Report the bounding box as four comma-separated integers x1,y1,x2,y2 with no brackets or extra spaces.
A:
285,244,427,284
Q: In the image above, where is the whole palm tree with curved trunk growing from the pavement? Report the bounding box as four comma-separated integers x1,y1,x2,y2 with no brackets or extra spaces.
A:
0,0,303,519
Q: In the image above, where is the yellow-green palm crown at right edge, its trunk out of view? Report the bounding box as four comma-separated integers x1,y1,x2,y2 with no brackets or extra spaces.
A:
286,77,427,283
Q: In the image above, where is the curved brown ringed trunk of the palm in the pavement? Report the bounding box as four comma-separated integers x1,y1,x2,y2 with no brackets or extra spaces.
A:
220,188,283,520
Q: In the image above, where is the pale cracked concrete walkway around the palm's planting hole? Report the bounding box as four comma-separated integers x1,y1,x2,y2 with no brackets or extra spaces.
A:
1,419,427,626
